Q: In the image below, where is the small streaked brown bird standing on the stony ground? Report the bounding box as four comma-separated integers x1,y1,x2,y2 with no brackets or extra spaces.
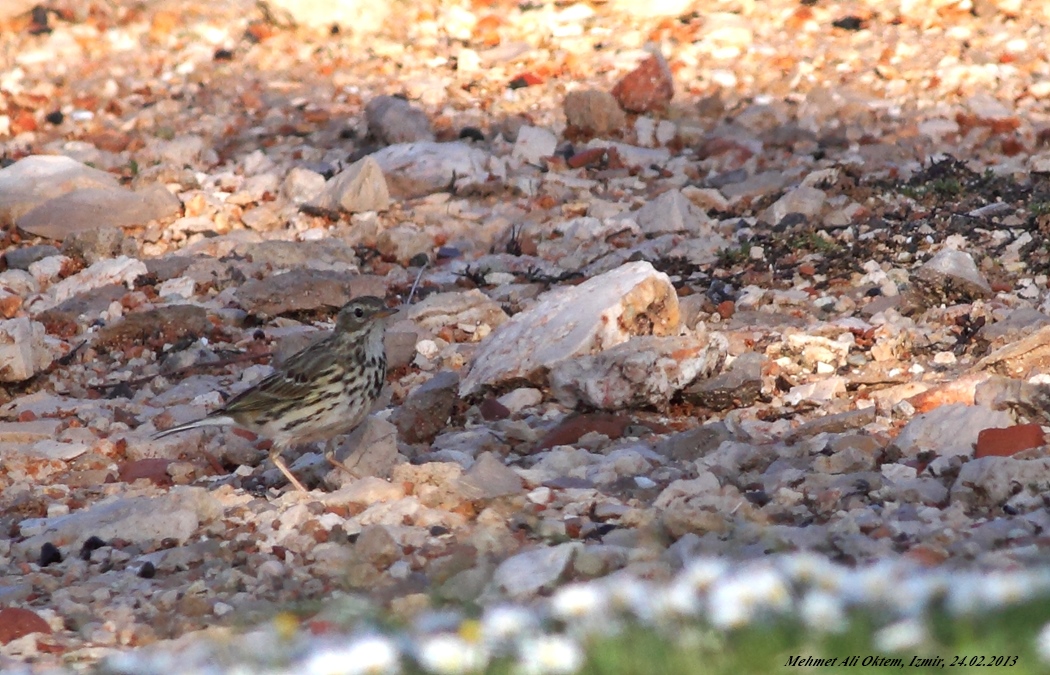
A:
153,296,397,491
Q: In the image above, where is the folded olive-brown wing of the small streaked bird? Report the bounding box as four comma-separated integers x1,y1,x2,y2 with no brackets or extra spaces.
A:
212,340,335,415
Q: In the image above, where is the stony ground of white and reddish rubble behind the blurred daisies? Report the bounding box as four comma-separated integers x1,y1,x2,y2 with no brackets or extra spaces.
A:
0,0,1050,672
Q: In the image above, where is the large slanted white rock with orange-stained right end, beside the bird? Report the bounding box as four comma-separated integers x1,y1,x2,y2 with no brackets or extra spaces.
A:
460,261,678,396
